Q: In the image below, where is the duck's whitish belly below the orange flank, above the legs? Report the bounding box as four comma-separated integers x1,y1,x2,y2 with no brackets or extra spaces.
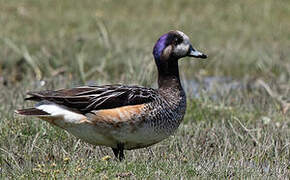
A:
64,121,168,149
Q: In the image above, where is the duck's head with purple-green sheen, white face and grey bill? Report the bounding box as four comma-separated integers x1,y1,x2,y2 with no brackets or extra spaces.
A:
153,30,207,65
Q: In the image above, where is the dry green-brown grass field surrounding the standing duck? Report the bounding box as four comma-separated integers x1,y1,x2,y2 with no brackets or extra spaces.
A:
0,0,290,179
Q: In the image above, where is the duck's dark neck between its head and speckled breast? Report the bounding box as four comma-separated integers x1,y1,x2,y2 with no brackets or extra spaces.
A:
157,59,182,90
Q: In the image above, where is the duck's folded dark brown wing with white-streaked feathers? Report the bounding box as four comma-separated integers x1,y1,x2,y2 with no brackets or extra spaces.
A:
26,85,159,113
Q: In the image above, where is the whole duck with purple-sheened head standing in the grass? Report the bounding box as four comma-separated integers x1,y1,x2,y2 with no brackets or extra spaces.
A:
15,30,207,161
